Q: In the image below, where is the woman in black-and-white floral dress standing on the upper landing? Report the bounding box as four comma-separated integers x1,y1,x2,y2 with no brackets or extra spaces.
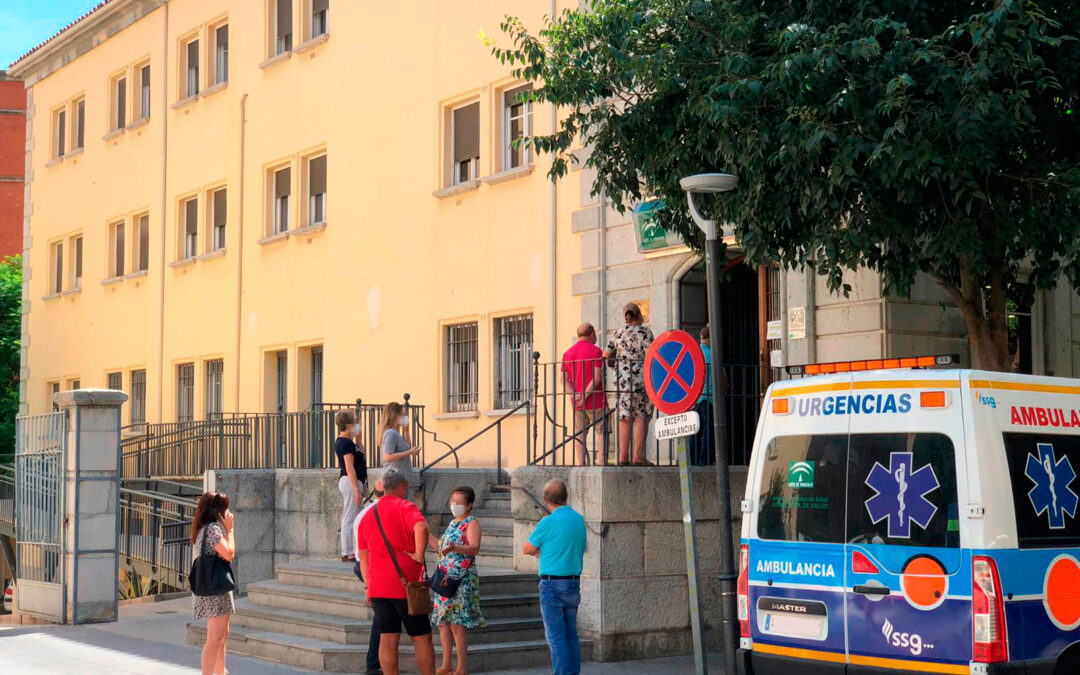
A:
604,302,652,467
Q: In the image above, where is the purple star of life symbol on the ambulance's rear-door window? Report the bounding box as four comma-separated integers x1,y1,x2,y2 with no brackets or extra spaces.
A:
866,453,941,539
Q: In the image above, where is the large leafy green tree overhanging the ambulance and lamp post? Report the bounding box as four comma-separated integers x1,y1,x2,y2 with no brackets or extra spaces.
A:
492,0,1080,369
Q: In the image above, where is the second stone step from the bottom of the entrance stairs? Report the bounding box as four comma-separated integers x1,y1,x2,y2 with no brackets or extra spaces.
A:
231,599,544,645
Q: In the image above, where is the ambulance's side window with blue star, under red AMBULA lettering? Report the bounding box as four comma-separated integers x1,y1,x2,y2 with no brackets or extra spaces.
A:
1002,432,1080,549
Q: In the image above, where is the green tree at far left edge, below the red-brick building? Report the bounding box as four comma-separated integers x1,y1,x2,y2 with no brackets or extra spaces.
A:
0,255,23,463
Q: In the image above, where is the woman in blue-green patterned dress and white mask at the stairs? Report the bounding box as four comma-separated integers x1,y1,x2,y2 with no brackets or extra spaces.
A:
430,487,487,675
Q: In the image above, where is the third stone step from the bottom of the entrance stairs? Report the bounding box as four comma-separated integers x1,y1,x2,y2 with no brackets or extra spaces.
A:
247,579,540,621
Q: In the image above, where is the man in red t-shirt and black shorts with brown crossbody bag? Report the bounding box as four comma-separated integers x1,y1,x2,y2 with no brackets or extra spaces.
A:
356,470,435,675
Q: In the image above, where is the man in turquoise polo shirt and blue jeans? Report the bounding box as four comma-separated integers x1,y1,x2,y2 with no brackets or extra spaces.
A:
524,481,585,675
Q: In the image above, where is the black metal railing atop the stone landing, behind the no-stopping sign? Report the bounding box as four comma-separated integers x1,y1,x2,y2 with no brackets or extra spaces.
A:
528,355,764,467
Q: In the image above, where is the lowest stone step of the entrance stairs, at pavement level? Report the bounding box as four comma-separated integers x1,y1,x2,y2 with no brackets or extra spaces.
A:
187,622,578,673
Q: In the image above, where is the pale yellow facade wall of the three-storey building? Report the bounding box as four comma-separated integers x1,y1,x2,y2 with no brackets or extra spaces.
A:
17,0,579,464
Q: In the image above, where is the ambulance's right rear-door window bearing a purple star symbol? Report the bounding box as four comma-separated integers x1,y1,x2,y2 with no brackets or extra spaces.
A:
848,433,960,549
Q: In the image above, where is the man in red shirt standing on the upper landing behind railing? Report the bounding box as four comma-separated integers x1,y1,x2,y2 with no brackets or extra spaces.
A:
563,323,607,465
